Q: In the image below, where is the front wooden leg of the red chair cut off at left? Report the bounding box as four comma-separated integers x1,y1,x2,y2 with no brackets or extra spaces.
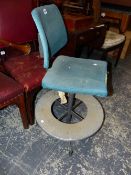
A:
17,94,29,129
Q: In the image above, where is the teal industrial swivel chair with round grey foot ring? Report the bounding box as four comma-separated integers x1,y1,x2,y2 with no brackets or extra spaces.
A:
32,4,107,154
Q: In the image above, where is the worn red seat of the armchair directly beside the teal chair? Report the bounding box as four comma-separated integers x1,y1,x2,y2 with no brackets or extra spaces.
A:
4,52,46,91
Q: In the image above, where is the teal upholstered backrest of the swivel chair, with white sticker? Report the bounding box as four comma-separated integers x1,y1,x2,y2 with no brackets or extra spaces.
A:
32,4,67,68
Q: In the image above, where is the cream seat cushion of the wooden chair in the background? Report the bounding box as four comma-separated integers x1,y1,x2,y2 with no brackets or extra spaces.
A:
102,30,125,49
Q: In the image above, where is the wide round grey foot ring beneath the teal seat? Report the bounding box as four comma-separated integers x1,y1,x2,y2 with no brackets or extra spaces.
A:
35,91,104,141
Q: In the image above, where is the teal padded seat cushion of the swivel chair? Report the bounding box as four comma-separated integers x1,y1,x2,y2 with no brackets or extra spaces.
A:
42,56,107,96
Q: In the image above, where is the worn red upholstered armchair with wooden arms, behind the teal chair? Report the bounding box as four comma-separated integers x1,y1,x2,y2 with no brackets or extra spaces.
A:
0,0,45,124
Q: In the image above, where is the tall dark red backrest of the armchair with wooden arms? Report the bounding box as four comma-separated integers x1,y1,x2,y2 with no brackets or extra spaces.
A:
0,0,37,45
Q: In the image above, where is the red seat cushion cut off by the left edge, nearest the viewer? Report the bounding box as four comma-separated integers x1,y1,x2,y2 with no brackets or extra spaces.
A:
0,72,24,103
